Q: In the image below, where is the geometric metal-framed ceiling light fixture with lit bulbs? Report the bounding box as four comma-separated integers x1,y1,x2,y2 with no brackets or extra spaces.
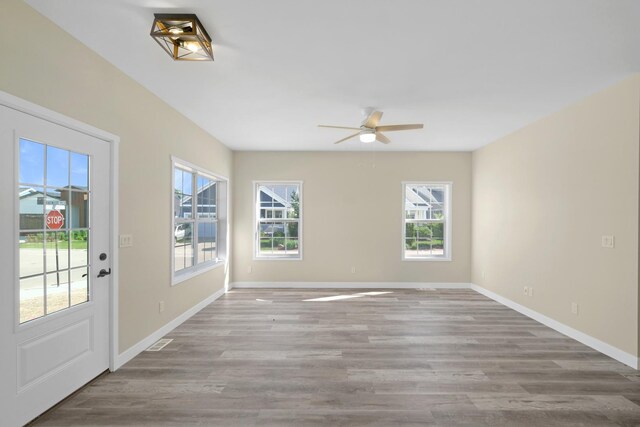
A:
151,13,213,61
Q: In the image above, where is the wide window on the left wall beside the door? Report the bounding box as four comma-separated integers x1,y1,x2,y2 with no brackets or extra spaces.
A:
171,159,227,284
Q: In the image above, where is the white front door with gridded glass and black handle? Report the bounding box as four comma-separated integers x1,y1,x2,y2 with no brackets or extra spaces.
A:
0,105,111,426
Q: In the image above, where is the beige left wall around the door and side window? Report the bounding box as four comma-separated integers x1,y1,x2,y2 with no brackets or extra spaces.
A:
0,0,232,351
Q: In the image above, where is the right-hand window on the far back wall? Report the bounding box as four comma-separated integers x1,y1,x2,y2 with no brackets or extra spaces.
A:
402,182,451,261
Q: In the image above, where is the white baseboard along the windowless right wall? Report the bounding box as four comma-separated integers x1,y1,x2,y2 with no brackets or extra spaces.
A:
470,284,639,369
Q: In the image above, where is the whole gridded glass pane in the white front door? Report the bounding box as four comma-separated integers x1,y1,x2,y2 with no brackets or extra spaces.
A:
18,139,91,323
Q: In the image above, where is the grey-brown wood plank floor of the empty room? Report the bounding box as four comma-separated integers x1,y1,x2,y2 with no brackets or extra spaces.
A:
34,289,640,427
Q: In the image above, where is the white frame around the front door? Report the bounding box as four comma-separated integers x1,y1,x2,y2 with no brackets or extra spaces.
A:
0,91,120,372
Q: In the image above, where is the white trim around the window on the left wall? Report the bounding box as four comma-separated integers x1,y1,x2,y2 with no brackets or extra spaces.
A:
169,156,229,286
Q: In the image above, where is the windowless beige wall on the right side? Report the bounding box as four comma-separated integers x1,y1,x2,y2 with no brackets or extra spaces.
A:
472,76,640,355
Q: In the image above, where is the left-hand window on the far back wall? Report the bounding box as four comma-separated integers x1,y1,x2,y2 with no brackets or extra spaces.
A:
254,182,302,260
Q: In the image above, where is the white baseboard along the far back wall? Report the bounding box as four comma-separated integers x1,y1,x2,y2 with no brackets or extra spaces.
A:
229,282,471,289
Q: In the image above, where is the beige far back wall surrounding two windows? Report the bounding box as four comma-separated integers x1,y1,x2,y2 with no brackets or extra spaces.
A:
232,151,471,283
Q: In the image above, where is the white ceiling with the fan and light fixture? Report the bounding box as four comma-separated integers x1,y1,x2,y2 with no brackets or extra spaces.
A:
27,0,640,150
